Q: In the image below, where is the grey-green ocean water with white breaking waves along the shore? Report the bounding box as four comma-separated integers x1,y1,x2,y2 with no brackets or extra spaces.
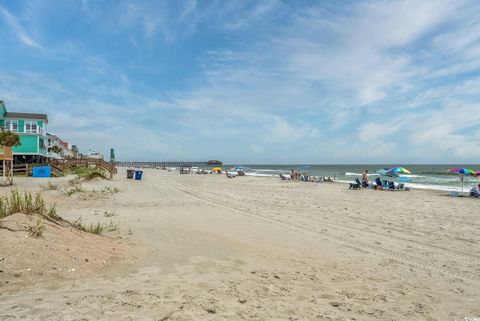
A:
223,164,480,192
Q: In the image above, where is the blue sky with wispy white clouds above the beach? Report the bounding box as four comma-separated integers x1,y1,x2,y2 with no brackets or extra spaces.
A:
0,0,480,164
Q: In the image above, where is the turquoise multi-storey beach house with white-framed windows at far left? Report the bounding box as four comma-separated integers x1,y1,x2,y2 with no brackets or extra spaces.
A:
0,100,48,163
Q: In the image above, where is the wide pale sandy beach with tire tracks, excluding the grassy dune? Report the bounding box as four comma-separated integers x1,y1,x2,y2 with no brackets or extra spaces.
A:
0,168,480,320
